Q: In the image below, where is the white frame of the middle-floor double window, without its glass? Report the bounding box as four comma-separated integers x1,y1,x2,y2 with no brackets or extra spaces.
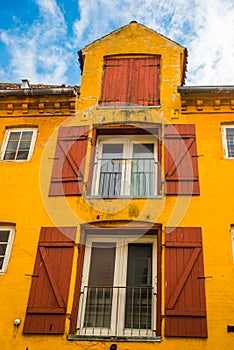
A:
91,135,158,198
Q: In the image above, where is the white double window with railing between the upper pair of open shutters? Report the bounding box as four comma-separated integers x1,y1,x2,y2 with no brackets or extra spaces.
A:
92,136,158,198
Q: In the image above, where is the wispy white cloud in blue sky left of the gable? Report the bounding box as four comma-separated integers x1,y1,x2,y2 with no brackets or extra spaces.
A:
0,0,70,83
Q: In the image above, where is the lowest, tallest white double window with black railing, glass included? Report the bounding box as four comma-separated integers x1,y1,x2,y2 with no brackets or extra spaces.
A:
77,235,157,337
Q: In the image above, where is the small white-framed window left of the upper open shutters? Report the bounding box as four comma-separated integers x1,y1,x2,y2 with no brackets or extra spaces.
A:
1,128,37,161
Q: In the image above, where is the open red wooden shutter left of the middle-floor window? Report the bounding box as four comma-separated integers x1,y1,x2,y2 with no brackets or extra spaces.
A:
49,126,88,196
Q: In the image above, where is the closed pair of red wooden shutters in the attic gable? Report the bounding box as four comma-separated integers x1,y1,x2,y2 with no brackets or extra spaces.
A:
99,56,160,106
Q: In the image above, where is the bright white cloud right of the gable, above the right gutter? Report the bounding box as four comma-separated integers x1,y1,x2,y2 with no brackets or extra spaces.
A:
189,0,234,85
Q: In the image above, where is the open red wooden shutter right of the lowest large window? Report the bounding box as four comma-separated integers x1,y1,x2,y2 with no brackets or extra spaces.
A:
165,227,207,338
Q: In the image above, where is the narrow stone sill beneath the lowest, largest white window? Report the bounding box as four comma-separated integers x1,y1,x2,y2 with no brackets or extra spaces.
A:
67,334,162,343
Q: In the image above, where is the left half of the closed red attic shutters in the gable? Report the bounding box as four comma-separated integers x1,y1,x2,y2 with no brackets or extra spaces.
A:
100,58,129,106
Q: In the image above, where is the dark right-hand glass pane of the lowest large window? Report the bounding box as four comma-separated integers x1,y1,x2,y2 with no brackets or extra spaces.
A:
125,244,152,329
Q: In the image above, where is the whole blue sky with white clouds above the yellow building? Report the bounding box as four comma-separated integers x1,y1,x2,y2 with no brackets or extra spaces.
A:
0,0,234,85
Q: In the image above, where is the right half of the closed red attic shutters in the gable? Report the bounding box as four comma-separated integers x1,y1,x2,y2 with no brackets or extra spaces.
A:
131,57,160,106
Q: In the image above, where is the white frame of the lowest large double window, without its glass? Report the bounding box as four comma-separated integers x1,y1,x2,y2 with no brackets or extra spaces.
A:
77,234,157,337
